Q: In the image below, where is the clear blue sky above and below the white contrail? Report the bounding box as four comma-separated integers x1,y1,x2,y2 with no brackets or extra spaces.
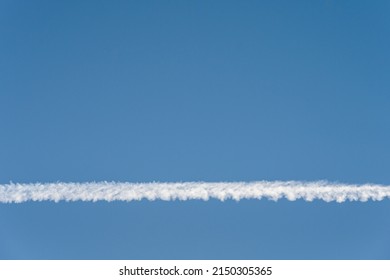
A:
0,1,390,259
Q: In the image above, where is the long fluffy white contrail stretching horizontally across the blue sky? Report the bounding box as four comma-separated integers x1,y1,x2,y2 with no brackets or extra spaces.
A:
0,181,390,203
